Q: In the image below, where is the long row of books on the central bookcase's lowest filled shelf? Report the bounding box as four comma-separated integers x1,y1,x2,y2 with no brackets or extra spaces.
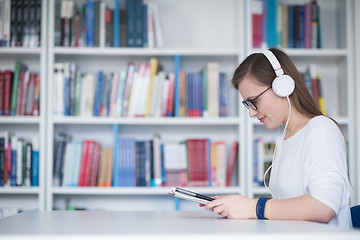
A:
53,133,238,187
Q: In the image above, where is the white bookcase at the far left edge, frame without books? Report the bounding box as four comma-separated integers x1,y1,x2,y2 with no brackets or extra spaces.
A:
0,0,48,211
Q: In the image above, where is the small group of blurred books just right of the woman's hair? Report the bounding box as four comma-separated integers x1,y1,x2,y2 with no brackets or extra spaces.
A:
301,64,326,115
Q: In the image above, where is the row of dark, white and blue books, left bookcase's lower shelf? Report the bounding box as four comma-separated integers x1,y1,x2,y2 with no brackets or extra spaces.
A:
0,131,39,187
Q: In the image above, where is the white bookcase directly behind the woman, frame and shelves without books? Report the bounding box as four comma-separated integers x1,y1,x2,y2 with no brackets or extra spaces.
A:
244,0,359,203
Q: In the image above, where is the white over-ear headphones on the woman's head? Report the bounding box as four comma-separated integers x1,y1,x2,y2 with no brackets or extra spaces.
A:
263,50,295,97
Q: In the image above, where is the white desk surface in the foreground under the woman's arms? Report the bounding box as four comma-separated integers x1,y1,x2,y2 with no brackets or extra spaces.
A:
0,210,360,240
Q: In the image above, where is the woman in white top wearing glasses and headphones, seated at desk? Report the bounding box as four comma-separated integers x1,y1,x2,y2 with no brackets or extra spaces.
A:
201,48,352,227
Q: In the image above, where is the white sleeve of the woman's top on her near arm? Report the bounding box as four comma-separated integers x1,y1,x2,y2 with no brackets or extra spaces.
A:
305,118,349,214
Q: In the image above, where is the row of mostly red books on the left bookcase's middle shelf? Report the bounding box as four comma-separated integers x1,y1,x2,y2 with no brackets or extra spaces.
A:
0,60,40,116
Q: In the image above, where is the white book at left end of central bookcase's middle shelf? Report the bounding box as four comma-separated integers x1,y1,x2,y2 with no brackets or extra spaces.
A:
52,63,65,115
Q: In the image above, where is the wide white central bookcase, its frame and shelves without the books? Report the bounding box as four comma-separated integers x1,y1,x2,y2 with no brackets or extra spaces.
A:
46,0,244,210
